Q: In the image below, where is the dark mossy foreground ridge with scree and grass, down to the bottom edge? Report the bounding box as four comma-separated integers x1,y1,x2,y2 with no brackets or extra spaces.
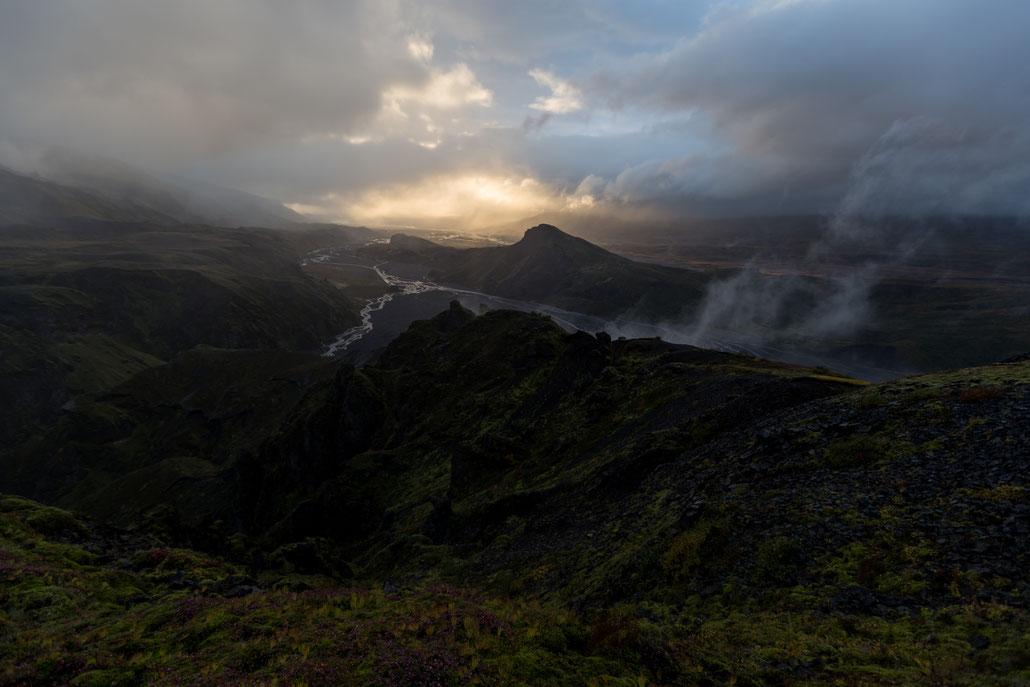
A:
0,305,1030,685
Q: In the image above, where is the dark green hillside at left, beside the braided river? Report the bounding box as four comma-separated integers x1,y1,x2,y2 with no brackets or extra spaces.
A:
0,219,368,448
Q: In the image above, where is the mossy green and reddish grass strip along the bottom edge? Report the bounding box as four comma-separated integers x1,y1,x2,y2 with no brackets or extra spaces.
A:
10,497,1030,687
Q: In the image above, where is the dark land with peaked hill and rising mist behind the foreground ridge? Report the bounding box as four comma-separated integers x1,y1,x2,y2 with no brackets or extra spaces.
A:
362,223,1030,379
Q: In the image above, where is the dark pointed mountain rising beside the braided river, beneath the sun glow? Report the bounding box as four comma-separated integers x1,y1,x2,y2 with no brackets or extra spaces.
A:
363,225,707,317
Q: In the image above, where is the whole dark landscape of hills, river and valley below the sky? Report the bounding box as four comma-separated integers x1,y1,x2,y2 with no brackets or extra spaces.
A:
0,163,1030,687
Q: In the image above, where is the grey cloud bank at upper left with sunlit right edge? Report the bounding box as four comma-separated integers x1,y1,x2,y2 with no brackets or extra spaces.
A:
0,0,510,215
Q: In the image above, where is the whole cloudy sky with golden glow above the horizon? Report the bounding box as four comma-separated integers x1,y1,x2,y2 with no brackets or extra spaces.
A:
0,0,1030,229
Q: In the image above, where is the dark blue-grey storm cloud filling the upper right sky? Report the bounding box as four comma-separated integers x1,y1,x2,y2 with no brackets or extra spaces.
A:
586,0,1030,212
